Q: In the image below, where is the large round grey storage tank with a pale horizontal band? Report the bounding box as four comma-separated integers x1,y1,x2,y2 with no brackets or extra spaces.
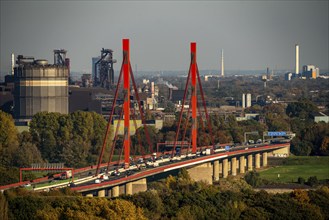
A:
14,50,69,120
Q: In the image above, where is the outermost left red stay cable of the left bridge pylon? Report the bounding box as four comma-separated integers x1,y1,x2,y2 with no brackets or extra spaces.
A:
95,56,126,176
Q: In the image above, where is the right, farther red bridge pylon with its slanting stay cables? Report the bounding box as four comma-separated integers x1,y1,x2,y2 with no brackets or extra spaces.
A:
172,42,214,156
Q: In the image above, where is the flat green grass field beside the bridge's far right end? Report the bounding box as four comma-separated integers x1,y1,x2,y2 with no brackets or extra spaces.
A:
259,156,329,183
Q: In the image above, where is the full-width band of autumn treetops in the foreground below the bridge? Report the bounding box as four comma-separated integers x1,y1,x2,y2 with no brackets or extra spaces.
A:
0,169,329,220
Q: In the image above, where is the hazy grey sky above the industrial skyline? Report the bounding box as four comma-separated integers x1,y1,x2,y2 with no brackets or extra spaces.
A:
0,0,329,71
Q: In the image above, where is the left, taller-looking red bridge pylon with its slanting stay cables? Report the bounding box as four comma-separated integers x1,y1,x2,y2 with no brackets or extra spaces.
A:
96,39,153,176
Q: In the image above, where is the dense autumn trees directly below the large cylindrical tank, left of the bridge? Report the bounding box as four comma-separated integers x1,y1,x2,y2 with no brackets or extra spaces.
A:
0,111,108,185
